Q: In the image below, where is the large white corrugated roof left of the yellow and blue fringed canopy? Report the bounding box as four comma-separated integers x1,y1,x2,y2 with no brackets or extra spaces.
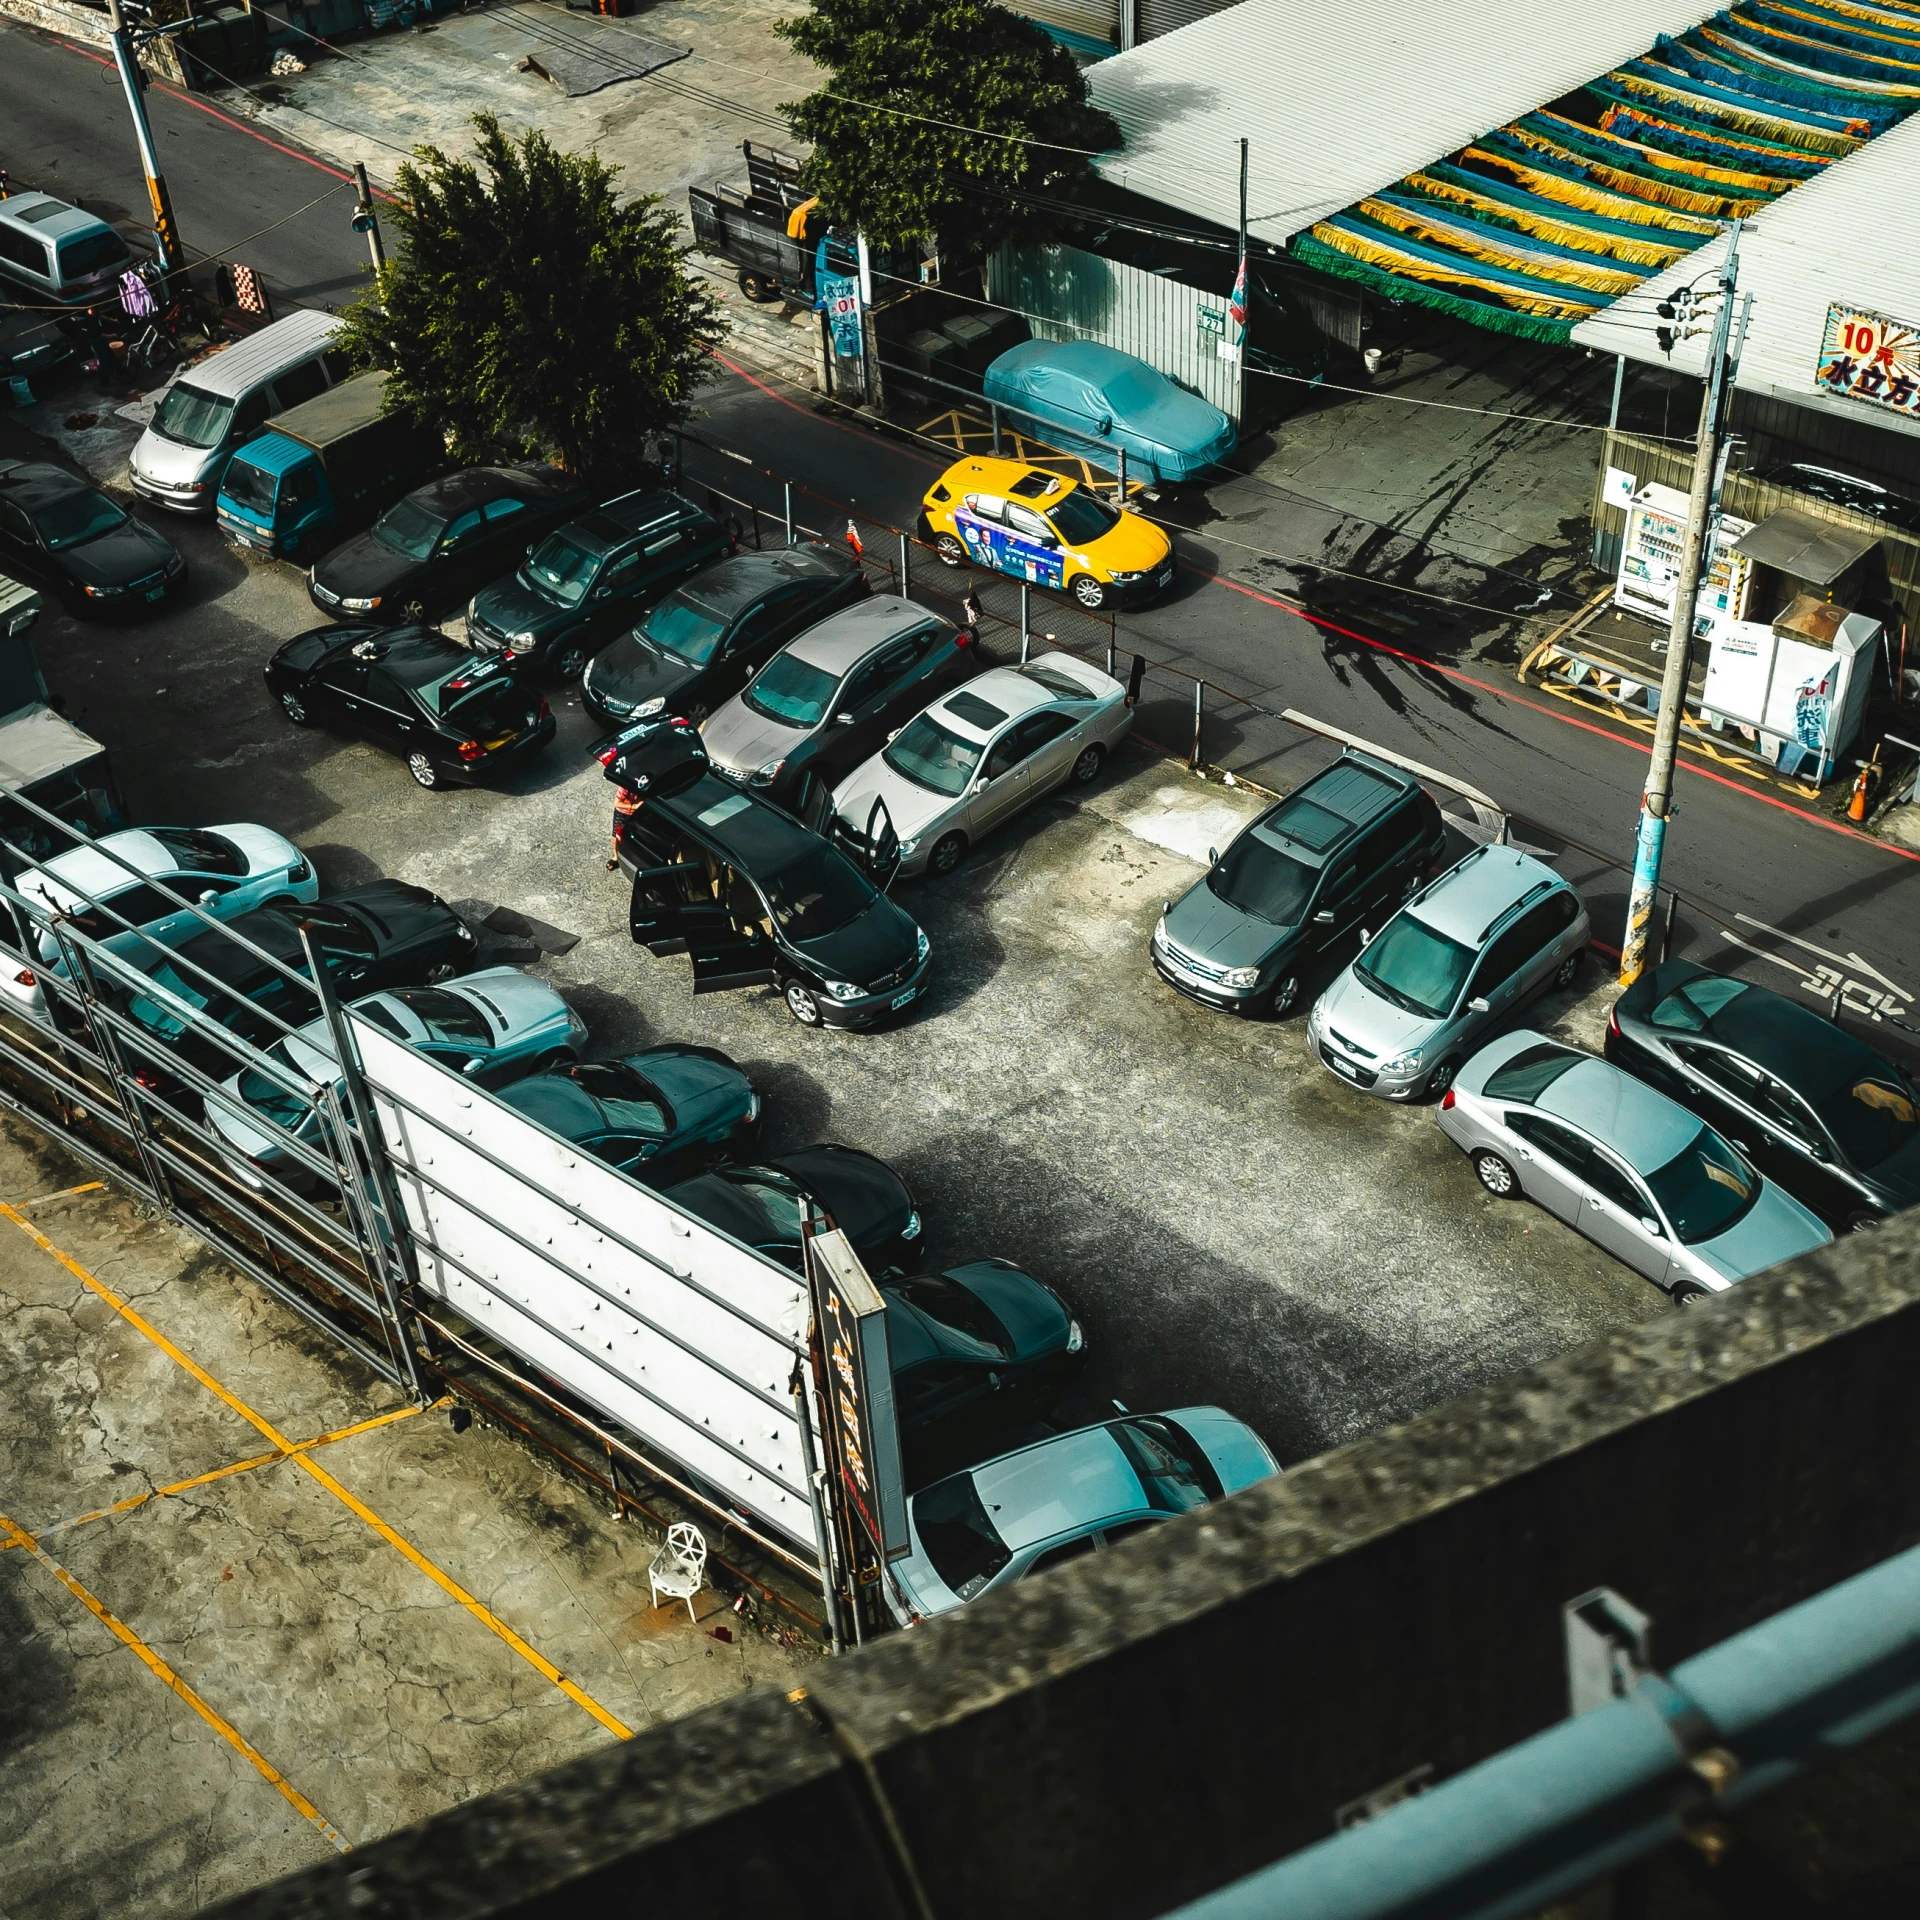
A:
1087,0,1716,244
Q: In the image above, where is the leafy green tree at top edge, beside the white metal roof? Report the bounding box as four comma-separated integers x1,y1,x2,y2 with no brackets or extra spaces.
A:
774,0,1119,253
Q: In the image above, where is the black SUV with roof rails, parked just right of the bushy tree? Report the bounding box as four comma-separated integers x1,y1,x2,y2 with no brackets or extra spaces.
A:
467,488,732,680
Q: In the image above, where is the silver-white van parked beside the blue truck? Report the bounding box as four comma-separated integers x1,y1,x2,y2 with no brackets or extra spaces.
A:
127,309,348,513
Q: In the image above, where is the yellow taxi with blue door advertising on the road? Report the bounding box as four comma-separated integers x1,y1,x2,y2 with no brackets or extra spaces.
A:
920,459,1173,612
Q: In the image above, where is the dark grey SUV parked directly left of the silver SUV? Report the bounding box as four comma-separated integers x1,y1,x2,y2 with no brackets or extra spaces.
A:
1150,749,1446,1016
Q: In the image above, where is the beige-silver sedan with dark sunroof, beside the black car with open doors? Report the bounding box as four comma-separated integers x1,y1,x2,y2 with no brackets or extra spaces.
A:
833,653,1133,874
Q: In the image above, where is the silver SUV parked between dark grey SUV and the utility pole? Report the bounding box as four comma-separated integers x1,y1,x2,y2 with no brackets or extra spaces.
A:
1308,847,1588,1100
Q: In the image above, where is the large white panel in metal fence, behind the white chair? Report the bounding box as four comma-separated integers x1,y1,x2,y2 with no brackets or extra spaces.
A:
351,1014,814,1551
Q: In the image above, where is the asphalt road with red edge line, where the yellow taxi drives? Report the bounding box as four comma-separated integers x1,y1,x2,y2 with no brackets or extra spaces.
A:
0,25,1920,1044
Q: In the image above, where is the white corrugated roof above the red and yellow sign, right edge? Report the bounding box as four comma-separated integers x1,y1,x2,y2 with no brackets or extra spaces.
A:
1572,115,1920,434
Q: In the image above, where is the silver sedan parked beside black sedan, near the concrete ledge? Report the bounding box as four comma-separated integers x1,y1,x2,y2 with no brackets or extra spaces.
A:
1438,1029,1834,1306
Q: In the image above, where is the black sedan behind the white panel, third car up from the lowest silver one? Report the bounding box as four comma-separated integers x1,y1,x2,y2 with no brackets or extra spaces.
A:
666,1146,920,1273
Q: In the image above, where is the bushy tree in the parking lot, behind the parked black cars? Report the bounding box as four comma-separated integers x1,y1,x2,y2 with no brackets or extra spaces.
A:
342,113,722,478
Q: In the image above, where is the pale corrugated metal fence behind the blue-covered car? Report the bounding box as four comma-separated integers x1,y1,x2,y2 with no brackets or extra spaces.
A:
987,244,1240,420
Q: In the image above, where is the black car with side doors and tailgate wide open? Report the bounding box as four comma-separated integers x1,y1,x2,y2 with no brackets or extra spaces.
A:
601,722,931,1027
